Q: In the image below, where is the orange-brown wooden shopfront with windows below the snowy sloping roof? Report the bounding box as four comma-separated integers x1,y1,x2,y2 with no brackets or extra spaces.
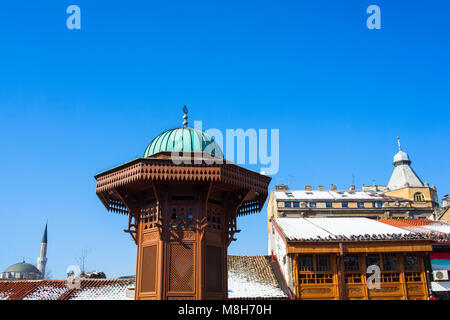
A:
287,240,431,300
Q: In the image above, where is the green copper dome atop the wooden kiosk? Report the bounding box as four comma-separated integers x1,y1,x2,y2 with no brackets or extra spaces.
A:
144,127,223,158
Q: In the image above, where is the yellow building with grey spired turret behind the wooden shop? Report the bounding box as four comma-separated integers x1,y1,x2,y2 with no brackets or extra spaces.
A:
267,141,439,220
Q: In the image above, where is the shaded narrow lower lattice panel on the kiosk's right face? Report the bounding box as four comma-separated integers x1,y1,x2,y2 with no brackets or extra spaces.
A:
206,246,223,292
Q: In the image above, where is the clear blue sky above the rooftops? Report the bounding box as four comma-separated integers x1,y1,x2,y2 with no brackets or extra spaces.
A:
0,0,450,278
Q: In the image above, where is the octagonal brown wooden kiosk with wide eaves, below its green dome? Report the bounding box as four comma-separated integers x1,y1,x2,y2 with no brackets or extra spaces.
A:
95,152,270,299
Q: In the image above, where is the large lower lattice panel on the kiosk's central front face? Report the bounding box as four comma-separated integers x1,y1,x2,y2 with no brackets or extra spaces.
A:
169,243,194,292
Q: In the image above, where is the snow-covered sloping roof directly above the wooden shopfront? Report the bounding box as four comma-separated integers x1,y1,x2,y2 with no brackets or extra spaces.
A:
274,217,425,241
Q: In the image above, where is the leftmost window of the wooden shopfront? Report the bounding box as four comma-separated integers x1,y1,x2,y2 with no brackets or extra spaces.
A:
297,254,334,284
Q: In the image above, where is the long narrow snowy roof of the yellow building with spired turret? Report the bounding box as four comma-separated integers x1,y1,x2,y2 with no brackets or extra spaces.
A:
273,190,399,201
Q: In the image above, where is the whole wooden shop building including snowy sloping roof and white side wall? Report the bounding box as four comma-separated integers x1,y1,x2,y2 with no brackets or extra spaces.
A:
269,218,432,300
